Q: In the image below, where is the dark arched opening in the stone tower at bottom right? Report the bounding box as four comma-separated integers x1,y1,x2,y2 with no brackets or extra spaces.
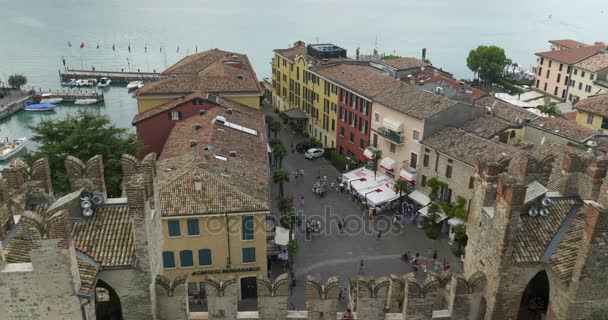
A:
517,270,549,320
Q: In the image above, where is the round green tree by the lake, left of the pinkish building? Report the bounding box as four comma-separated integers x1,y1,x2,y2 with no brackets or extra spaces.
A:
467,46,507,84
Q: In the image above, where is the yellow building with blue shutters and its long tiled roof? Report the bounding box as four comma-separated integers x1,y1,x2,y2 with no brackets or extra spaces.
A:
158,98,270,300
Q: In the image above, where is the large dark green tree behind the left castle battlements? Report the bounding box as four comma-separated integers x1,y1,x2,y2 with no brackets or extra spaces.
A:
23,112,141,197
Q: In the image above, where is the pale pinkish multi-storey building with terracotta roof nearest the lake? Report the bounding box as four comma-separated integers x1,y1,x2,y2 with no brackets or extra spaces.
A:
534,39,606,101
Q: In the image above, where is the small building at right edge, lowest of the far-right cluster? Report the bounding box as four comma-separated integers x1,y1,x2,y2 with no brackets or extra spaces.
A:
574,94,608,133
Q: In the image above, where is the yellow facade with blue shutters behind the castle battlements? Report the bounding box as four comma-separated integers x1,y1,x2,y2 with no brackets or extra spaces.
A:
162,211,269,298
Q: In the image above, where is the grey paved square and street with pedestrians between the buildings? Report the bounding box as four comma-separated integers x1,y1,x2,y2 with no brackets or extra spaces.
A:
264,105,460,310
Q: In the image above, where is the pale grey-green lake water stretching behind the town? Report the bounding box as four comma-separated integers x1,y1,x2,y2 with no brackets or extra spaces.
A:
0,0,608,164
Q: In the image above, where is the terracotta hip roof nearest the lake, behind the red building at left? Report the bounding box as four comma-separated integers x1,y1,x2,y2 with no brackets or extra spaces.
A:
134,49,263,97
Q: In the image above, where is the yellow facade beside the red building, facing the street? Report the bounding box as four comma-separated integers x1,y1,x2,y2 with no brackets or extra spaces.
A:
272,46,338,148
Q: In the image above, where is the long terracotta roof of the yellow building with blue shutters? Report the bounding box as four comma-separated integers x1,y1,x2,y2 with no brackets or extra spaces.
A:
157,99,270,216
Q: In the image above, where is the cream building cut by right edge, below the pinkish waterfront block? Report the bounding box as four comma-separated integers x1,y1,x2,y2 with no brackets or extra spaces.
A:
568,52,608,104
